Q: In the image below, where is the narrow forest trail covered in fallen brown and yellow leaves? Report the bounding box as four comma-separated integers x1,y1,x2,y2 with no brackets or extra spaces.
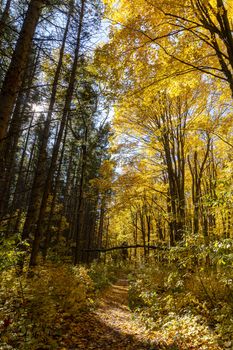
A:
61,279,159,350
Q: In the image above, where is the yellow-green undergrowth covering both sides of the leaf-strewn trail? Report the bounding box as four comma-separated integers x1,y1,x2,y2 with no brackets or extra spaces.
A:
0,240,233,350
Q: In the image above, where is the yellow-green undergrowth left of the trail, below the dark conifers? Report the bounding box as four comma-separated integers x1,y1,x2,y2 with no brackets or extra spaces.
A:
0,263,119,350
